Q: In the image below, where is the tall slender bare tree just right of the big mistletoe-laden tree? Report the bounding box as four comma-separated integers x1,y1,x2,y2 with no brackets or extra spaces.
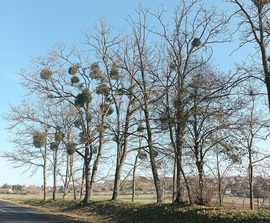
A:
86,20,139,200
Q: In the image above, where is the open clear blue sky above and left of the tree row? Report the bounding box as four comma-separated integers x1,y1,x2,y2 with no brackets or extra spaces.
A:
0,0,245,186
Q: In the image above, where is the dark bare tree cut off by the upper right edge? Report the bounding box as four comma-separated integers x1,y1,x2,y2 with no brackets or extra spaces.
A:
228,0,270,109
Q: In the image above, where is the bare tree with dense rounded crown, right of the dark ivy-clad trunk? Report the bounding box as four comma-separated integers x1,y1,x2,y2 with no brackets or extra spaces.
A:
185,62,242,204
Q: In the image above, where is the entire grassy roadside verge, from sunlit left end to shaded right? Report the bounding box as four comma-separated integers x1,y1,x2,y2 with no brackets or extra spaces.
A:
0,195,270,223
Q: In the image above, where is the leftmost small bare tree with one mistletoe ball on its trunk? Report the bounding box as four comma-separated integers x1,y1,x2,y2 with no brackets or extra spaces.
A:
2,103,53,200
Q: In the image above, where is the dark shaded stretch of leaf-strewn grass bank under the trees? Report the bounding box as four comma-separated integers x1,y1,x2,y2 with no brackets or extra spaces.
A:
63,201,270,223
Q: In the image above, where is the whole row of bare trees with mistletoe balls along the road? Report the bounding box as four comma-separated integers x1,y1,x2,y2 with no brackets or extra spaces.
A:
4,0,269,208
